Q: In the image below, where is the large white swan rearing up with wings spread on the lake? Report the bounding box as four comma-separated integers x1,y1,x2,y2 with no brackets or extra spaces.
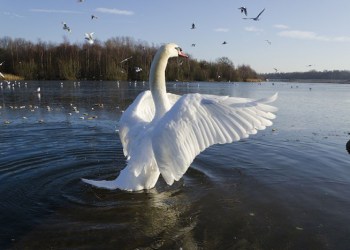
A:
82,43,277,191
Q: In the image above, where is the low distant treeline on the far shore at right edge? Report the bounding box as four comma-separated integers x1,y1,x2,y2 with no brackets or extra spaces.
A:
262,70,350,81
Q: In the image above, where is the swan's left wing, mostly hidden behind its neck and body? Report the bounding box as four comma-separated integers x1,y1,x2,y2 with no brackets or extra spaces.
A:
119,90,180,156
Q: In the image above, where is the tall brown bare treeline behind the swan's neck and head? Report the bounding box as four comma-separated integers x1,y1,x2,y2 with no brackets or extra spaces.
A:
0,37,259,81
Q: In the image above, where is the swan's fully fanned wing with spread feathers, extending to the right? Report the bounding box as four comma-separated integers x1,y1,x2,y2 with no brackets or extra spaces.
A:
152,94,277,185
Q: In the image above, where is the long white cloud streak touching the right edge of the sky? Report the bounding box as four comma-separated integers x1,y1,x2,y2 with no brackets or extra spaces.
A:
278,30,350,42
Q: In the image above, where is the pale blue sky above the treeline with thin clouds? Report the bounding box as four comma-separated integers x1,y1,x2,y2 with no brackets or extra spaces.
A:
0,0,350,73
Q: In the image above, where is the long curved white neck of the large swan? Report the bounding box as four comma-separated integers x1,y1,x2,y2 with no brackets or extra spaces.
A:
149,51,170,119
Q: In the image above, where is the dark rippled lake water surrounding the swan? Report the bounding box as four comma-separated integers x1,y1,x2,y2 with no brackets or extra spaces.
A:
0,82,350,249
